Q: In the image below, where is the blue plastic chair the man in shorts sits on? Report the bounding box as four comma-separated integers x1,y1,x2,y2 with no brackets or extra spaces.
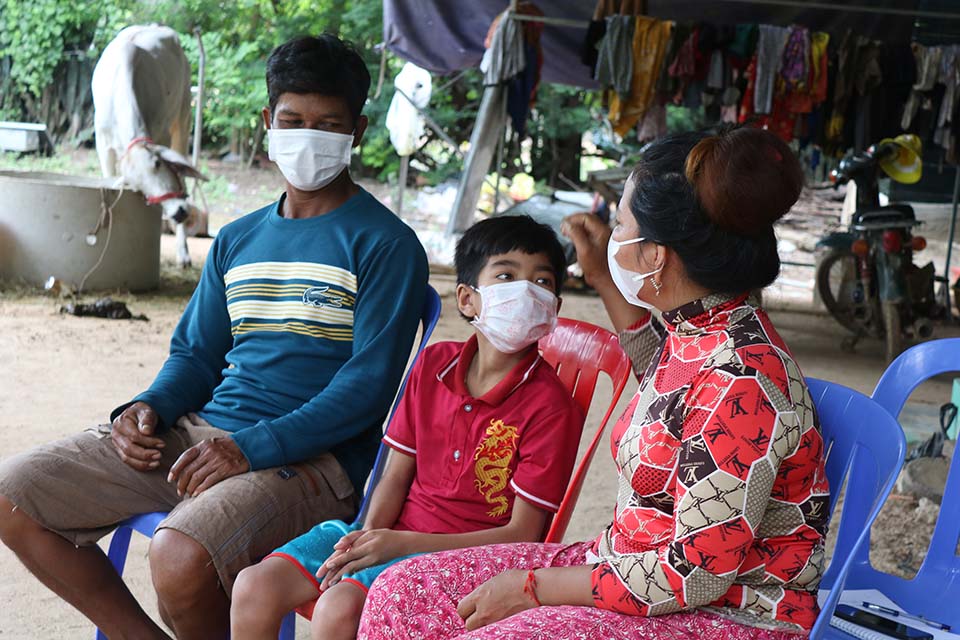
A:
96,285,441,640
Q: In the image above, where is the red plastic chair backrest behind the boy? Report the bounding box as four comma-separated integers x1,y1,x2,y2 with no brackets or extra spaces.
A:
540,318,631,542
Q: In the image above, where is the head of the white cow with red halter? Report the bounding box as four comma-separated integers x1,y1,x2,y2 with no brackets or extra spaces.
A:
120,138,207,222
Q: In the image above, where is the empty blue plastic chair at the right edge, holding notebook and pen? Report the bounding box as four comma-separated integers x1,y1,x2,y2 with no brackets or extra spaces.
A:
816,338,960,629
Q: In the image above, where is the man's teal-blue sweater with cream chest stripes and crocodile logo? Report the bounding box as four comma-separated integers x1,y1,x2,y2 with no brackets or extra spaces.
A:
125,190,428,488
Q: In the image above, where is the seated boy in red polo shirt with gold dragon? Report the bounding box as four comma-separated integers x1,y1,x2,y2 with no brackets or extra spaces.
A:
230,216,584,640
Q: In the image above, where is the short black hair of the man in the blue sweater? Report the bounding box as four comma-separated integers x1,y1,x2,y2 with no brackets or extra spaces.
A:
267,33,370,122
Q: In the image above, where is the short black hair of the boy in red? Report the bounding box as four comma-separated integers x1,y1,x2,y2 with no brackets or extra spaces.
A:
453,216,567,295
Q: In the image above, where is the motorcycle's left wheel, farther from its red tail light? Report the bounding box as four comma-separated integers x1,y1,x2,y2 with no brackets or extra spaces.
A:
817,249,882,337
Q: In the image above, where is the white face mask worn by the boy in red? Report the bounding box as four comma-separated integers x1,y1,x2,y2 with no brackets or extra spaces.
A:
470,280,557,353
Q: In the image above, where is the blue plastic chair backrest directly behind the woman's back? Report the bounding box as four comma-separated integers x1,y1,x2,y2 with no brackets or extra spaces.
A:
807,378,907,638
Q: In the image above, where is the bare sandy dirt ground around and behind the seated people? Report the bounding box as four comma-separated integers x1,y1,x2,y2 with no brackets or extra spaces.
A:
0,228,955,640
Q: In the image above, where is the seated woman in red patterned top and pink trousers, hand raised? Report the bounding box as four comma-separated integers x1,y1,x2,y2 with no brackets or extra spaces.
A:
359,128,829,640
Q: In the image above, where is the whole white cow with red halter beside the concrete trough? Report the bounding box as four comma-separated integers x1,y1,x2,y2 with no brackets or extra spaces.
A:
92,25,206,267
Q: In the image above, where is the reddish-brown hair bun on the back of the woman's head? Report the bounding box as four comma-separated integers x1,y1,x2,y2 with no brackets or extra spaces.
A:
685,127,803,237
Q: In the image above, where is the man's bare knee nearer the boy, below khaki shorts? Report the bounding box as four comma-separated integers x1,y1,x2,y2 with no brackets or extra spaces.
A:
150,529,220,604
